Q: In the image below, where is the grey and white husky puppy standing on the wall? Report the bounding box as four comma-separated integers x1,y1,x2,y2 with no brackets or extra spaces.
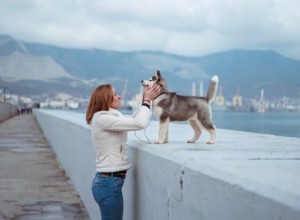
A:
141,71,219,144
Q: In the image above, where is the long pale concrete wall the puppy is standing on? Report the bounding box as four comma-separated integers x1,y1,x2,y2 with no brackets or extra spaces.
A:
34,110,300,220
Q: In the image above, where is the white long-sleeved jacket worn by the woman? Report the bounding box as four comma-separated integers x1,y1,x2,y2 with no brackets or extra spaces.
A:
91,106,151,172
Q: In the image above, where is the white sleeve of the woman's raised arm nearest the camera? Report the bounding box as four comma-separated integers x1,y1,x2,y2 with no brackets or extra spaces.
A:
96,106,151,131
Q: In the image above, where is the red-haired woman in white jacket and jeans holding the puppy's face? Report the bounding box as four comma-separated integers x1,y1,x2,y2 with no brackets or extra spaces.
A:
86,84,160,220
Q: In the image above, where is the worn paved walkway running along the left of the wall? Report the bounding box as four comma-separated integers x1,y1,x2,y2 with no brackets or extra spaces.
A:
0,114,89,220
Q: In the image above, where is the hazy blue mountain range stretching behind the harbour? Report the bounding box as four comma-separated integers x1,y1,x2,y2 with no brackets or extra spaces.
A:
0,35,300,99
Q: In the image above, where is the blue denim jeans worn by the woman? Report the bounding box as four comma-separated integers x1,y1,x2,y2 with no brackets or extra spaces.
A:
92,173,124,220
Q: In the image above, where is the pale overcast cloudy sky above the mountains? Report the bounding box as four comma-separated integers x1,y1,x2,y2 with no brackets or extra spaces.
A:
0,0,300,60
